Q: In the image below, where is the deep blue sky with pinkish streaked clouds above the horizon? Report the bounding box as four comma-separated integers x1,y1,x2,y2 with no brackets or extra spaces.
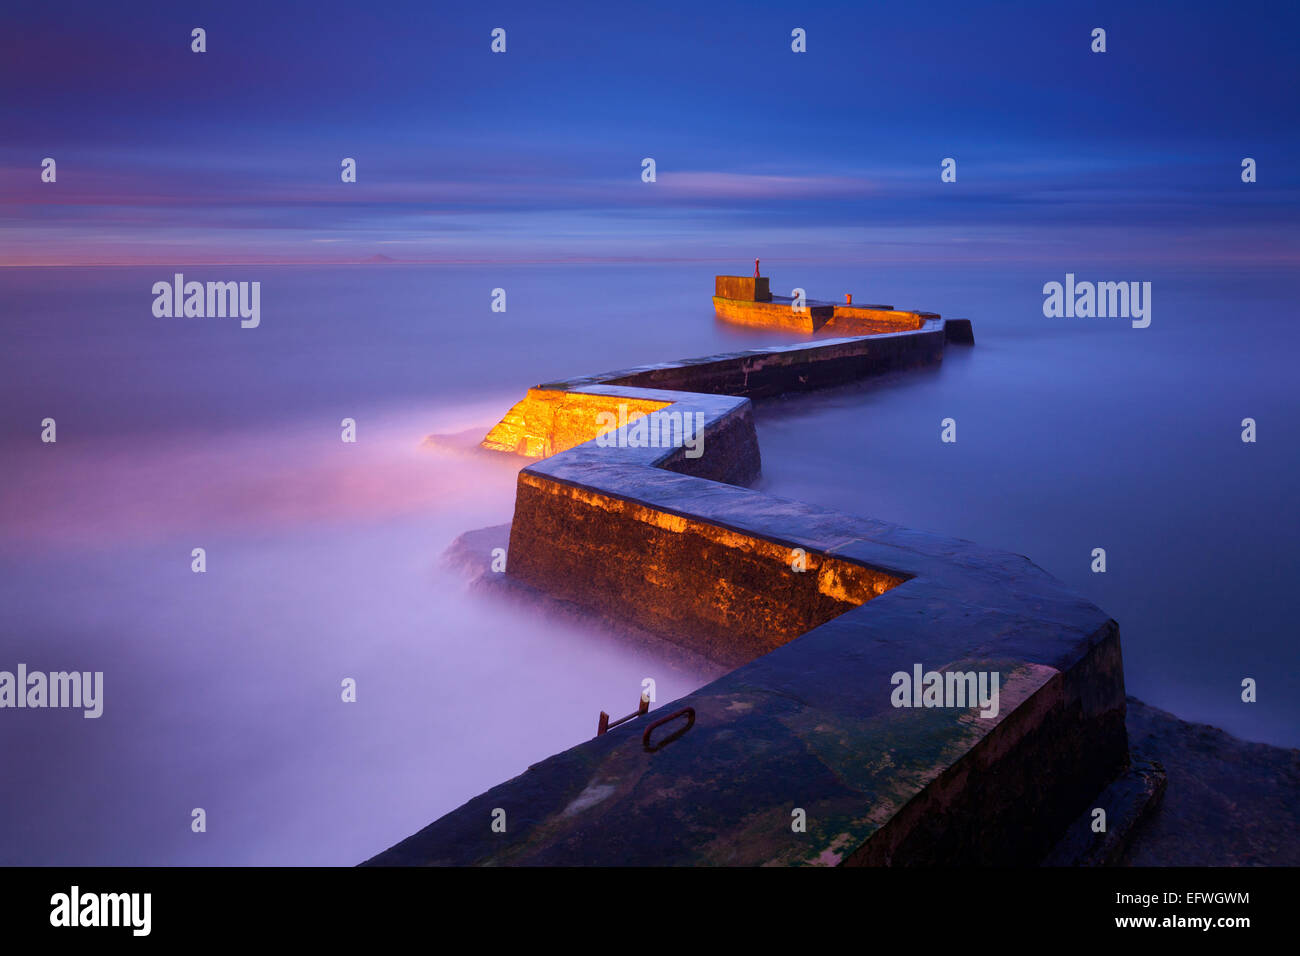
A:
0,0,1300,265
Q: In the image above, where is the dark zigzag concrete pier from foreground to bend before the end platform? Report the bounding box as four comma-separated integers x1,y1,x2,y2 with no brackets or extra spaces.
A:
371,313,1149,865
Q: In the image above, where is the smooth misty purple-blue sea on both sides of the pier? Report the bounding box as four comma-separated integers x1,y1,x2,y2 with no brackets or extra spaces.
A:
0,263,1300,865
